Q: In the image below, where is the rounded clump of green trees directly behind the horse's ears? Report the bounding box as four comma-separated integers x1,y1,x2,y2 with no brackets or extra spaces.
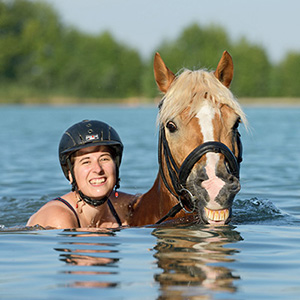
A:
143,24,272,97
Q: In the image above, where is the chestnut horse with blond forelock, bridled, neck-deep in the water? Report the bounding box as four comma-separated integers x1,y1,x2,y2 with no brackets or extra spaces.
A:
129,51,246,226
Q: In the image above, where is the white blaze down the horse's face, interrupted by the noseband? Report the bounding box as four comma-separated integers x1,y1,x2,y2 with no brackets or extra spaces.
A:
196,101,225,210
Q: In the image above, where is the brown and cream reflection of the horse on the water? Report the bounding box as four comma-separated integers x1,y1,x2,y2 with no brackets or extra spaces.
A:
152,226,242,299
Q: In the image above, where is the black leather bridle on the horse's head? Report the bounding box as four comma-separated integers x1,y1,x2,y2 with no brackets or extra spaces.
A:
156,125,242,224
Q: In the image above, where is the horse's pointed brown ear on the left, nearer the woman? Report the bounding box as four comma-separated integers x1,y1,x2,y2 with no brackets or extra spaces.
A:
153,52,176,93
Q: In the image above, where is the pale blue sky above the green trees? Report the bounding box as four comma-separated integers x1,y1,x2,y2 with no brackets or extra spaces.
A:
43,0,300,62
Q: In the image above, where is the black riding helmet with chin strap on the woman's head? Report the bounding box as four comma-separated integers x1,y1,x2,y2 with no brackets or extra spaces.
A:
58,120,123,206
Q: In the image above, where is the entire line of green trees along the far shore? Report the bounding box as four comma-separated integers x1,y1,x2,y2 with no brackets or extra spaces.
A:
0,0,300,103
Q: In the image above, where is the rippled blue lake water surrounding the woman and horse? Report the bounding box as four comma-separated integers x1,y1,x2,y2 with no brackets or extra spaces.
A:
0,106,300,300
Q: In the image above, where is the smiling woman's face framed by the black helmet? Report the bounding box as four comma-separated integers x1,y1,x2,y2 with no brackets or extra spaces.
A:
74,146,116,199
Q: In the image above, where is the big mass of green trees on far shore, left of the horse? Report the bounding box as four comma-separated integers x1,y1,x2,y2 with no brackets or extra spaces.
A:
0,0,143,98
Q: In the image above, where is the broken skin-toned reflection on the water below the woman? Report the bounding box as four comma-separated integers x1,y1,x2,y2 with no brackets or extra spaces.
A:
54,230,119,288
